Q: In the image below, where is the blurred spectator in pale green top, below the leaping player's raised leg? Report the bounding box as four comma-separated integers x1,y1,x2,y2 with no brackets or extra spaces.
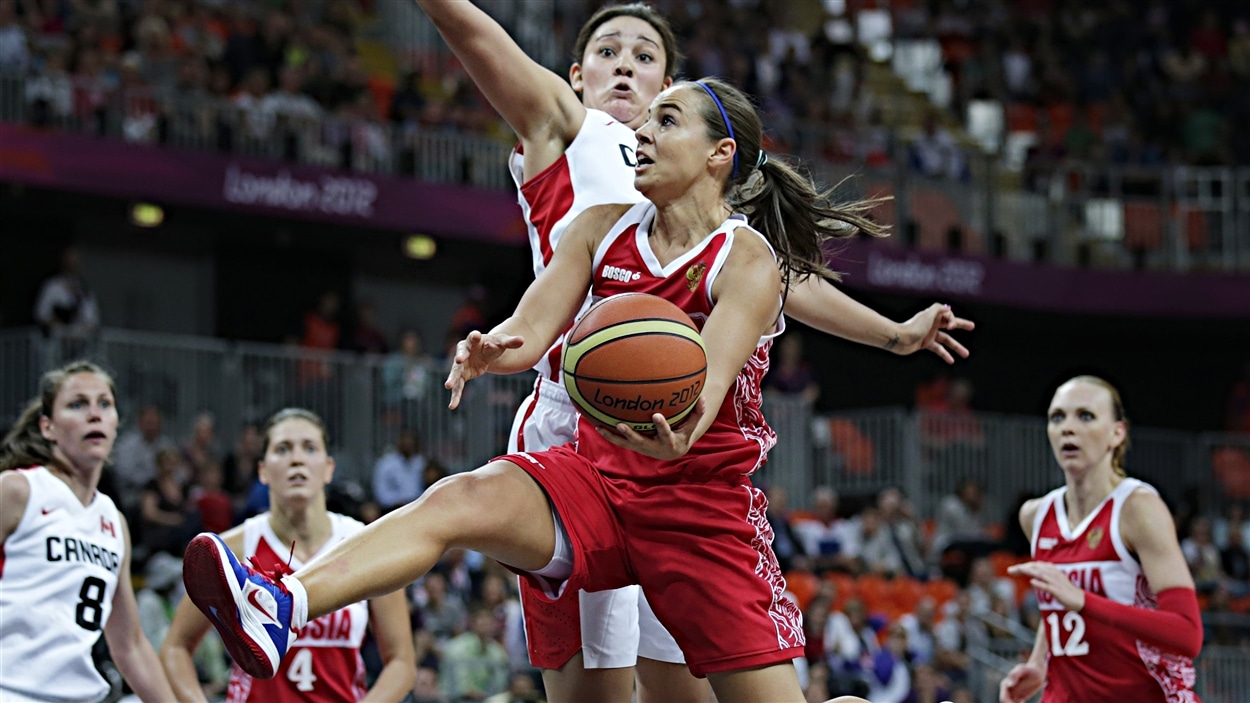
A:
439,608,508,700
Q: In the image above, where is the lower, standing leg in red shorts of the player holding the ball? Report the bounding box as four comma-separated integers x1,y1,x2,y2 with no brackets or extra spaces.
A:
635,482,804,703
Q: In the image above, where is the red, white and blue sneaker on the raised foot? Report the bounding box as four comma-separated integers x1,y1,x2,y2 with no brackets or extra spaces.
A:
183,533,298,679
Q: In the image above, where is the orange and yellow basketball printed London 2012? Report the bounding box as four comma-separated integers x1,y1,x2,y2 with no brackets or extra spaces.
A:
563,293,708,434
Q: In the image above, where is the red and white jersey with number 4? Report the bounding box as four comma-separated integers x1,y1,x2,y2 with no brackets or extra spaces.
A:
226,513,369,703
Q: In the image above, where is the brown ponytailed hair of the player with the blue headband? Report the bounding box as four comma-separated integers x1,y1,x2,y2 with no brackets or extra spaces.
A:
685,78,888,290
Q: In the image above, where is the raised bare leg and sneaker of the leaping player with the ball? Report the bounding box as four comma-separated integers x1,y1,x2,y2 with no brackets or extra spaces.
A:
183,460,557,678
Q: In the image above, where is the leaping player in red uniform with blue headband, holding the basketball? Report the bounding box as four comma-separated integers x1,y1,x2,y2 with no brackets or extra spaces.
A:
186,79,910,703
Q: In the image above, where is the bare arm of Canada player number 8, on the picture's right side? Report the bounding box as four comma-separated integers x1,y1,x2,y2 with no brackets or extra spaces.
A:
104,518,175,703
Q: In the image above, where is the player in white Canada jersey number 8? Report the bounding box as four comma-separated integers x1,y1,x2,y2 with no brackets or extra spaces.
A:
0,362,174,703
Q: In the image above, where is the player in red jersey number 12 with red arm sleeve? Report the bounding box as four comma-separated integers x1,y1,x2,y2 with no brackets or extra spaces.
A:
999,377,1203,703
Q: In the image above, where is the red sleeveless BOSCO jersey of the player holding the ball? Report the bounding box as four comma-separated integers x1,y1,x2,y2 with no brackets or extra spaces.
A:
578,203,784,479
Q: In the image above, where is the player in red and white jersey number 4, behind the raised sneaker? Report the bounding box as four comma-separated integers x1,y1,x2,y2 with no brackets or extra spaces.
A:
161,408,416,703
